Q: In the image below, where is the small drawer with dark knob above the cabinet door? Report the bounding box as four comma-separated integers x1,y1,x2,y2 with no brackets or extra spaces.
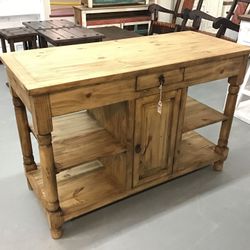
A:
136,69,184,90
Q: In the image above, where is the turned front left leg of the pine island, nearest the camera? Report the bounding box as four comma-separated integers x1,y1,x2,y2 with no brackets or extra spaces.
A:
31,95,64,239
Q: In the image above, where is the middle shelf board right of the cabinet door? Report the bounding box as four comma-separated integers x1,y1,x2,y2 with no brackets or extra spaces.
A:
183,97,227,133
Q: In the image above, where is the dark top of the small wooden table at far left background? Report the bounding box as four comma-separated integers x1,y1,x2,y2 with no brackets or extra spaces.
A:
0,27,37,39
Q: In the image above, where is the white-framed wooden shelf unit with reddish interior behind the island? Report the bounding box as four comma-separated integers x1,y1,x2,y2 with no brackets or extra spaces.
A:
74,4,150,35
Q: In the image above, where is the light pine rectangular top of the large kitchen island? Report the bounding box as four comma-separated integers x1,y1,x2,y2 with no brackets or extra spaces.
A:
1,31,250,95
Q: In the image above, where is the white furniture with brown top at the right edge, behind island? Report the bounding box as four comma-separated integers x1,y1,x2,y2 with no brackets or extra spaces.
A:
235,15,250,124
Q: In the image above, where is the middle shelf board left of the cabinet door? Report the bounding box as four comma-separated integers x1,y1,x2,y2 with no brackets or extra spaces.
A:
52,111,126,172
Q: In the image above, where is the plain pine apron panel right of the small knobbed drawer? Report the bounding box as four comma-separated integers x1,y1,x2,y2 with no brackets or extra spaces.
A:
184,57,242,84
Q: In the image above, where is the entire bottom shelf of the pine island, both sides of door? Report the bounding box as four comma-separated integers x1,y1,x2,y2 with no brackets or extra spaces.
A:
27,131,222,221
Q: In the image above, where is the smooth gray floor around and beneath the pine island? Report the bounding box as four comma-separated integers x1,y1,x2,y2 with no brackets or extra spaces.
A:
0,66,250,250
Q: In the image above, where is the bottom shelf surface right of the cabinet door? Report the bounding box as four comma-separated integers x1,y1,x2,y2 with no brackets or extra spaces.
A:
174,131,222,173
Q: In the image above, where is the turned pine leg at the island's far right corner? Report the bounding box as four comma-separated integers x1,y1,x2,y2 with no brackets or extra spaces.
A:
213,77,240,171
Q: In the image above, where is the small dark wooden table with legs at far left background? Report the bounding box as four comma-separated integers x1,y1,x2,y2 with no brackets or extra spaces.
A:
0,27,37,53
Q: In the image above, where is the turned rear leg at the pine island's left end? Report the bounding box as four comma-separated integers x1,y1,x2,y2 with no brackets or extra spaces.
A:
11,90,37,190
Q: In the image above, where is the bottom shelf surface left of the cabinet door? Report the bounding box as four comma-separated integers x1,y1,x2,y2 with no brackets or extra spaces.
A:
27,161,123,221
